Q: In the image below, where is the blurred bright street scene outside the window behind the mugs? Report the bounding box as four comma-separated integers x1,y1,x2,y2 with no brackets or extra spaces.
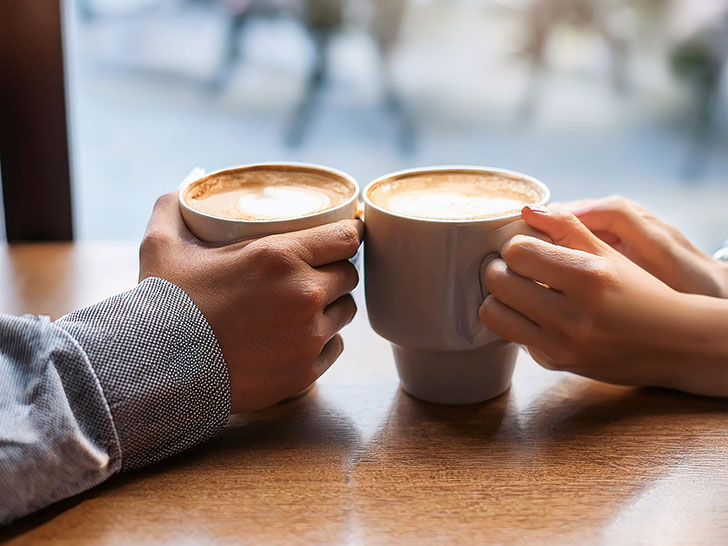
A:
64,0,728,252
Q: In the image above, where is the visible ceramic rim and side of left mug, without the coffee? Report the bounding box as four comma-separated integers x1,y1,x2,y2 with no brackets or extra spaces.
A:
179,162,359,243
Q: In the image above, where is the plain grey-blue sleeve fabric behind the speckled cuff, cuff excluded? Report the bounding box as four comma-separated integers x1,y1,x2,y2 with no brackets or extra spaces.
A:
0,316,121,524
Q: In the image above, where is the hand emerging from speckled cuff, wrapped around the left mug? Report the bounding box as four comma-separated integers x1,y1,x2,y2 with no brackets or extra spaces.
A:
139,193,364,413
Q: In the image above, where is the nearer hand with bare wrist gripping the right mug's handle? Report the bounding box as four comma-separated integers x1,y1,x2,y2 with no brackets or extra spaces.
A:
480,207,728,396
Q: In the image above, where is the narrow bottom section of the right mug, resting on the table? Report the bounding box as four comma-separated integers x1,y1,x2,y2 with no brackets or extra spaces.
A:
392,341,518,405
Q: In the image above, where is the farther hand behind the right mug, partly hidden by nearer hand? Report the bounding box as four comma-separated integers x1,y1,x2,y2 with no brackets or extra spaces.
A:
555,197,728,298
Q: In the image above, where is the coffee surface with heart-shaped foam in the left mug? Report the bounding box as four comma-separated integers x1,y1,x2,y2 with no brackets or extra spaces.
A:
184,168,355,222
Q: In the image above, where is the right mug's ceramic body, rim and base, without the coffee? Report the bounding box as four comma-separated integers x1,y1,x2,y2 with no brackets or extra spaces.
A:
363,166,550,404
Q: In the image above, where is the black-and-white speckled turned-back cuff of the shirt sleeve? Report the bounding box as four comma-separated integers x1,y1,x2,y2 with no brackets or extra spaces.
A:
57,278,230,469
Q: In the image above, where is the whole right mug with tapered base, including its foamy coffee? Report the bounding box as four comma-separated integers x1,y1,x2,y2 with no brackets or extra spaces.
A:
363,166,550,404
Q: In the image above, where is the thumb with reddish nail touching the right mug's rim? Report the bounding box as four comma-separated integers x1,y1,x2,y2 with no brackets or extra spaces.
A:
521,206,605,254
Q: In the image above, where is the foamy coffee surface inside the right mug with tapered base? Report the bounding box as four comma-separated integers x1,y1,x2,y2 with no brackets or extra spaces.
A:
367,171,543,220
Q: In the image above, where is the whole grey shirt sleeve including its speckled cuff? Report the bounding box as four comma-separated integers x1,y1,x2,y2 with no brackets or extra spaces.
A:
0,278,230,524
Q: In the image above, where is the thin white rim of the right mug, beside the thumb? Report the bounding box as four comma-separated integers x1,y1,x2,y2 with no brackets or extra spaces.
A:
361,165,551,224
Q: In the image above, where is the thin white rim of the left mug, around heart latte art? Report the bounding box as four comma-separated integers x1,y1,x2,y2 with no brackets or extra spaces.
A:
177,161,361,226
